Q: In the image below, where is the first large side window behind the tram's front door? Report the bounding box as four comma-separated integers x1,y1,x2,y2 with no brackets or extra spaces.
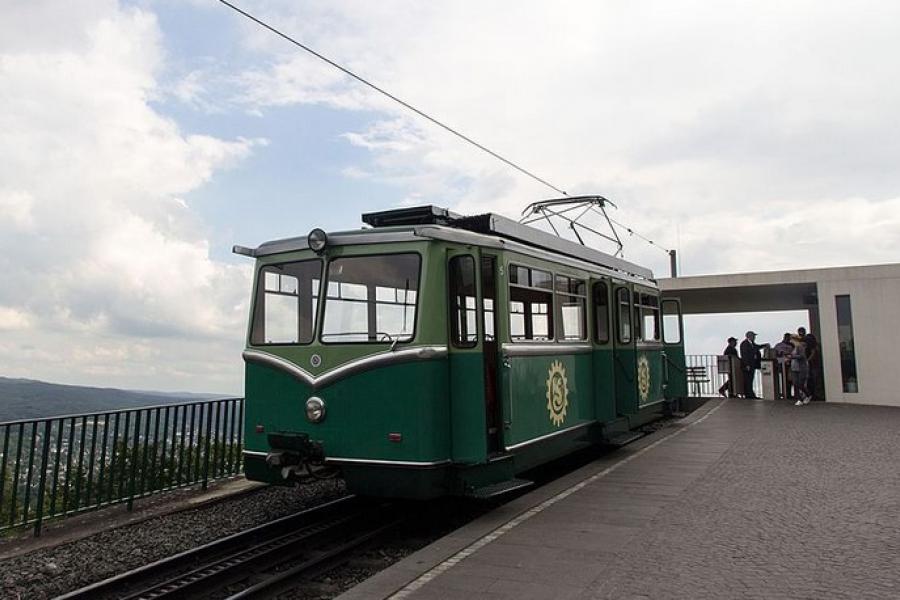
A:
509,265,553,342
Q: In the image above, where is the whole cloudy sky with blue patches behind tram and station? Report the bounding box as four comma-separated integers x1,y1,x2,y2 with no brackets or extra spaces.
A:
0,0,900,394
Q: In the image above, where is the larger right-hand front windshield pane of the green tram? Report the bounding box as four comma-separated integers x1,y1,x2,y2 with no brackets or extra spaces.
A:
321,254,421,343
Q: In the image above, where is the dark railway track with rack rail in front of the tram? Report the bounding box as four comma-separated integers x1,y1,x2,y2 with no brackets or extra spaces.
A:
57,496,402,600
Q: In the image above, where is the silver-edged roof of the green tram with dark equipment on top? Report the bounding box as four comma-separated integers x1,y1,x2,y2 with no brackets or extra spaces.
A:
234,206,653,281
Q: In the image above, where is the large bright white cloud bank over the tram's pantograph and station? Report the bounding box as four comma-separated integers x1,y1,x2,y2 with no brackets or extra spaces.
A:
230,1,900,273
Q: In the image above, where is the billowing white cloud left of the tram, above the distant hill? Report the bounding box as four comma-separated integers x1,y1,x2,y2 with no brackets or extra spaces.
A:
0,1,265,392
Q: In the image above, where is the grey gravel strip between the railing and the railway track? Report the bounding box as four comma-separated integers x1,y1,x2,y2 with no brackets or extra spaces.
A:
0,480,346,600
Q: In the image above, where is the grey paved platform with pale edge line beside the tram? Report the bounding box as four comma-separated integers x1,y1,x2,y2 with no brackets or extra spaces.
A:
340,400,900,600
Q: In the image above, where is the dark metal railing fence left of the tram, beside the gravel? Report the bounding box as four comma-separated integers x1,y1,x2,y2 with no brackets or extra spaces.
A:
0,398,244,535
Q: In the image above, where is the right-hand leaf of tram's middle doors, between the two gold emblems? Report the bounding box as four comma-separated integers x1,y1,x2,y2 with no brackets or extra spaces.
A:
612,283,638,416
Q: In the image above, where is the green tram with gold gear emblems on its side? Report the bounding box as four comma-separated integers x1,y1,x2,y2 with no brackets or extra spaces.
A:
234,206,687,499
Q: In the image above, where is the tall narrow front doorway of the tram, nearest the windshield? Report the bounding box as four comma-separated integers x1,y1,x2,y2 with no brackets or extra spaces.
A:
447,250,501,463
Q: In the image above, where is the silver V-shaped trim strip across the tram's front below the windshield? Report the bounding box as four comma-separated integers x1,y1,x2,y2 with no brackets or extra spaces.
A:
242,346,447,390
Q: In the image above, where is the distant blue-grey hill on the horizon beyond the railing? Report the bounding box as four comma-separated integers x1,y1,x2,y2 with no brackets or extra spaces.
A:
0,377,227,422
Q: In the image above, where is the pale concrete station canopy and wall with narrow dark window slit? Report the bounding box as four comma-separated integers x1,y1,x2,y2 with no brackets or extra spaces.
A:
659,264,900,406
